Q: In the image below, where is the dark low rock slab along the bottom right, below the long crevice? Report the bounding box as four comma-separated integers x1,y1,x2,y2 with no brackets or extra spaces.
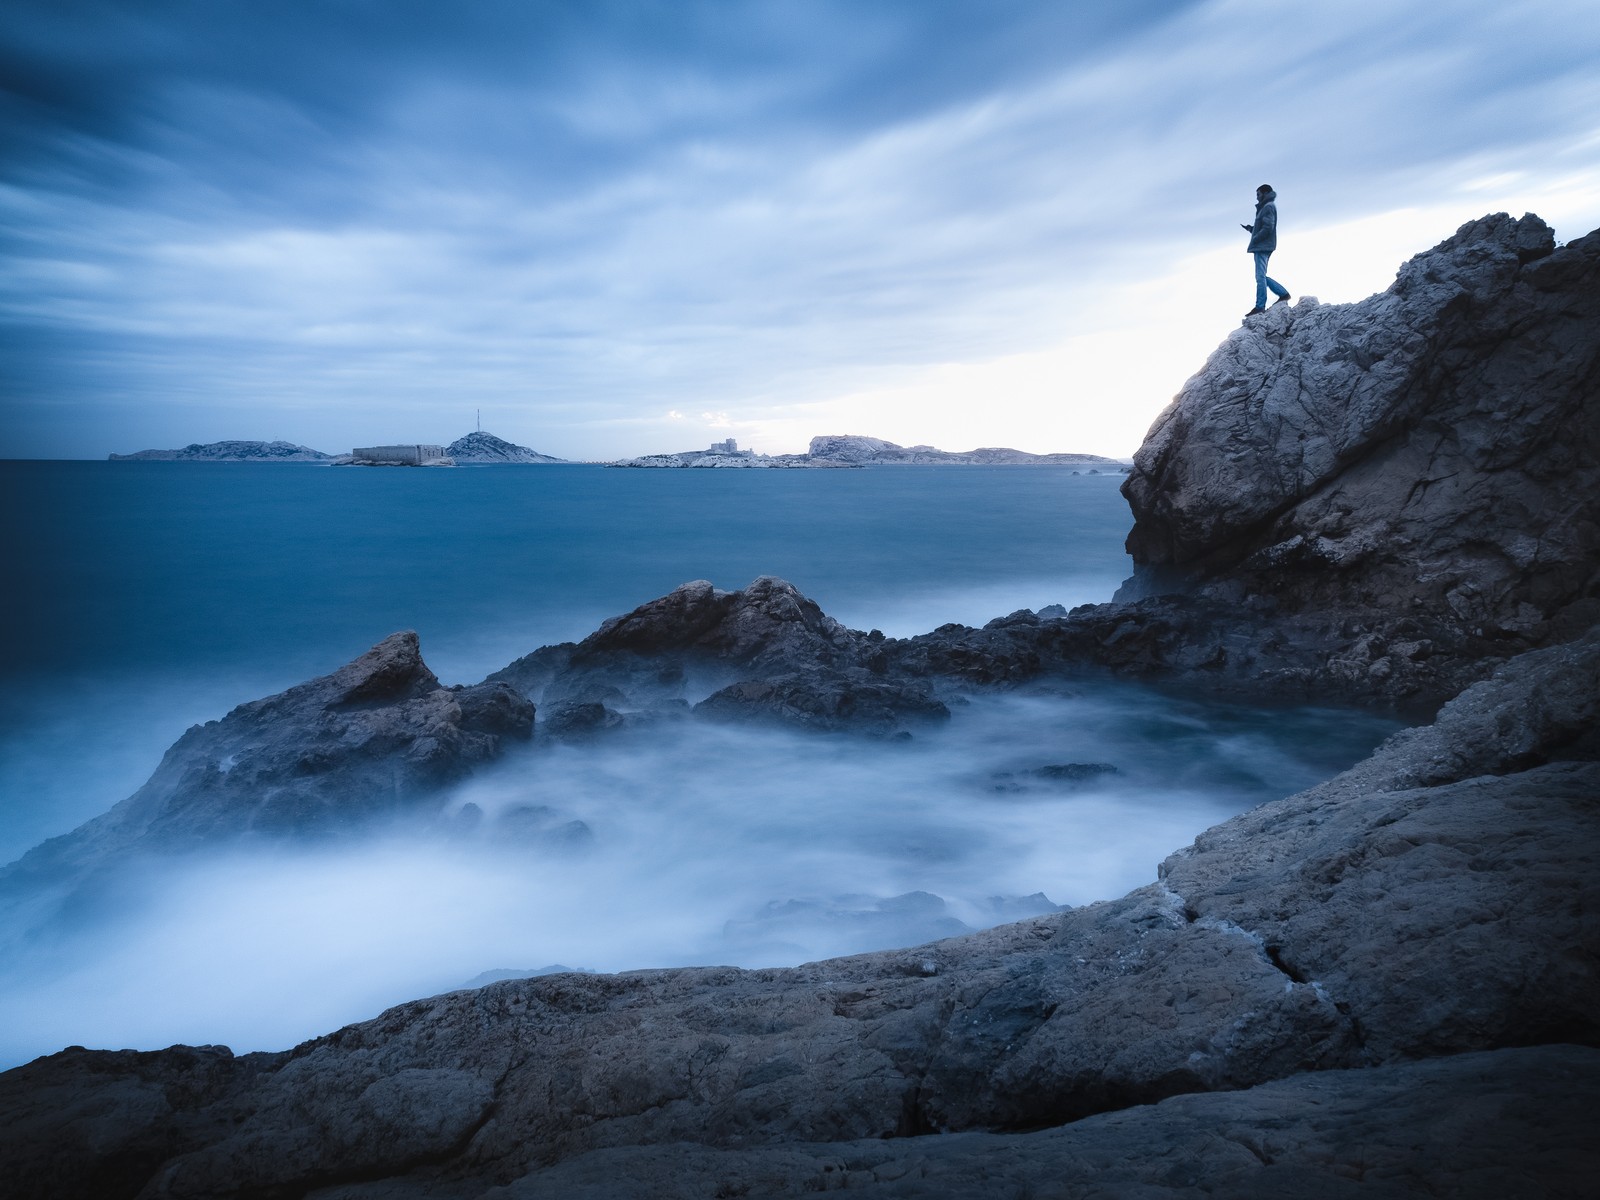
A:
492,1046,1600,1200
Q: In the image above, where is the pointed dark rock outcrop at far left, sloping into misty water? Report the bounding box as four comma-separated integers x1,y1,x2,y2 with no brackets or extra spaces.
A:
0,632,534,934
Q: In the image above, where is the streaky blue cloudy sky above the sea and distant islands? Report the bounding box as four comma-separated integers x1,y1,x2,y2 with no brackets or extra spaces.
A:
0,0,1600,459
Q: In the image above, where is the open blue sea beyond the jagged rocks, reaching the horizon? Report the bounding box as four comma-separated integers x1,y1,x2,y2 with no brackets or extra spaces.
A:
0,462,1128,861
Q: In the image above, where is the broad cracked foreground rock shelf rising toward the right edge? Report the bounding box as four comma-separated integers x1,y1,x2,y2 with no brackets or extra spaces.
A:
0,635,1600,1197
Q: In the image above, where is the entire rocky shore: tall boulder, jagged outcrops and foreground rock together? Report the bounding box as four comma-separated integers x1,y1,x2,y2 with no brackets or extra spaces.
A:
0,214,1600,1200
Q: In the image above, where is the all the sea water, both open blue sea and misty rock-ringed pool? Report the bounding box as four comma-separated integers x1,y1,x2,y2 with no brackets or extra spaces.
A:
0,461,1395,1066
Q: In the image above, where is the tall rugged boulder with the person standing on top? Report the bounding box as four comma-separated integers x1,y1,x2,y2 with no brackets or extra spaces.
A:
1123,214,1600,653
